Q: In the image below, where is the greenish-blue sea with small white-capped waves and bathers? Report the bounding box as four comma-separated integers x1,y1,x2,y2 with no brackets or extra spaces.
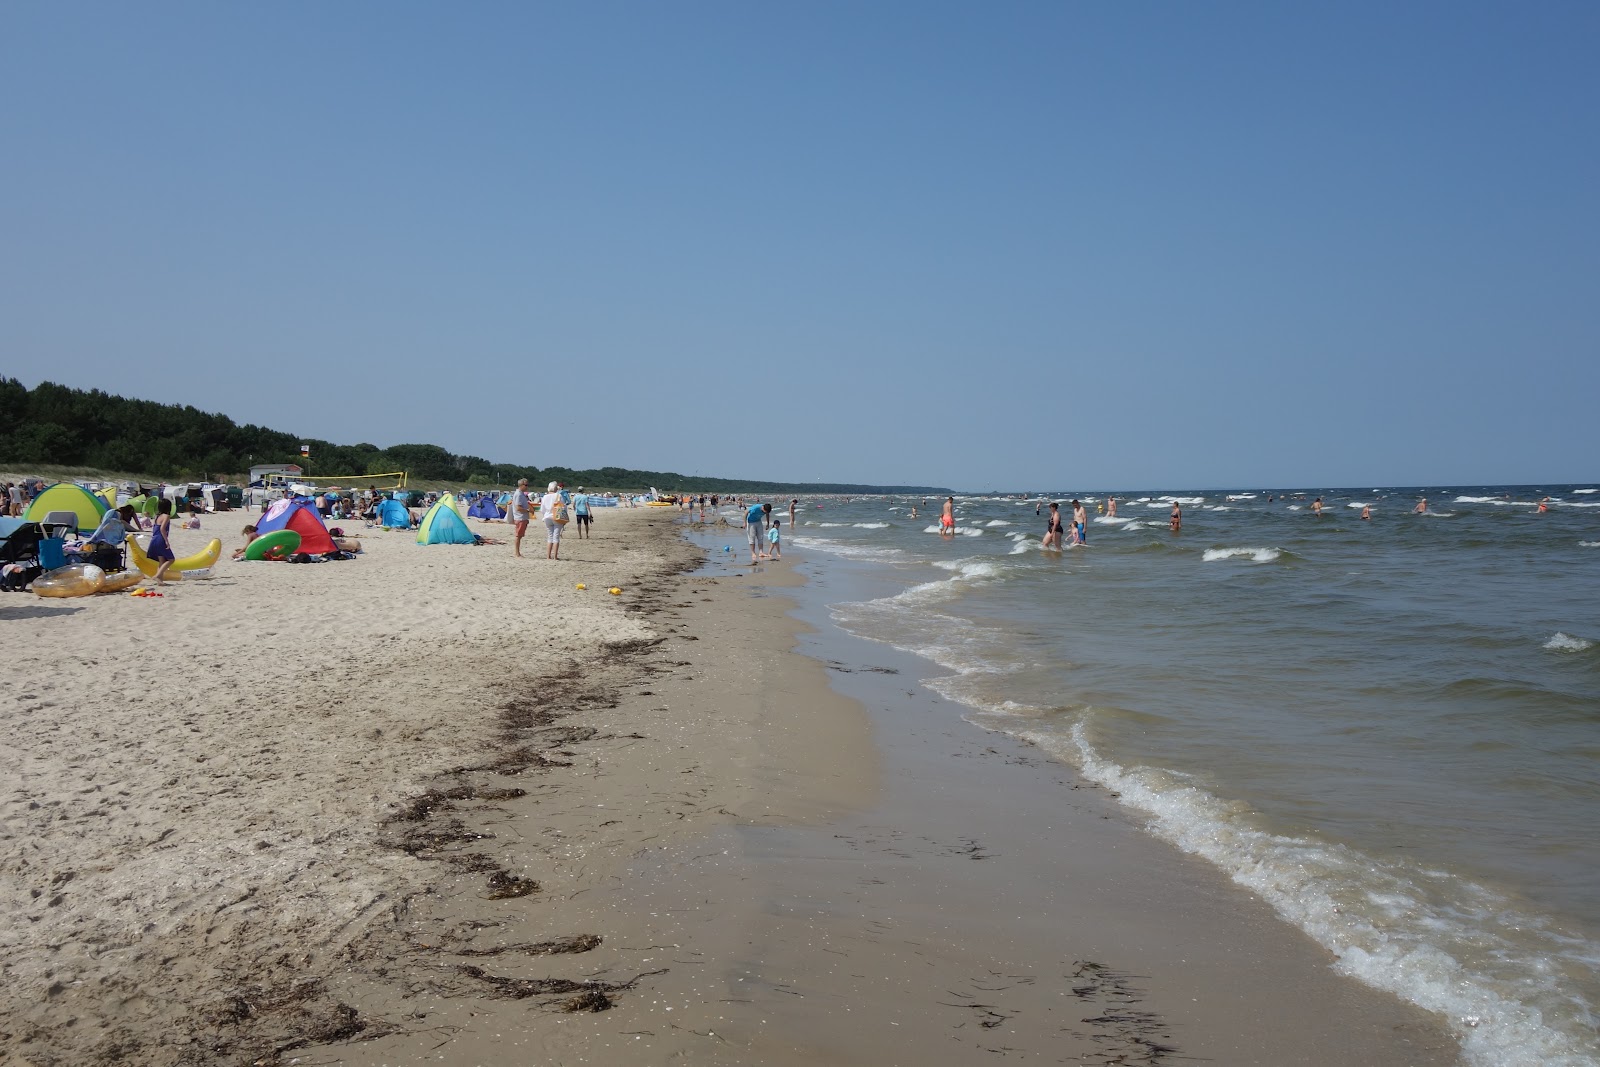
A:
725,485,1600,1067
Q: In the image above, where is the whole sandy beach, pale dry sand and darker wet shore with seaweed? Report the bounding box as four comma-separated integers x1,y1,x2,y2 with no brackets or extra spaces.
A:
0,509,1456,1067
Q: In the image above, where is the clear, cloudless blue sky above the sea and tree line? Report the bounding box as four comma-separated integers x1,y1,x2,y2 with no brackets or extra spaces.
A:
0,0,1600,490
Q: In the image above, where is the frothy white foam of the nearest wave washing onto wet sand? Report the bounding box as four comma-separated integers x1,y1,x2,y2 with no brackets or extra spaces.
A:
1019,721,1597,1067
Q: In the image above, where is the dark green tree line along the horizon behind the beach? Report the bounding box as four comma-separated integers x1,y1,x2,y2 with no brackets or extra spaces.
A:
0,378,946,494
